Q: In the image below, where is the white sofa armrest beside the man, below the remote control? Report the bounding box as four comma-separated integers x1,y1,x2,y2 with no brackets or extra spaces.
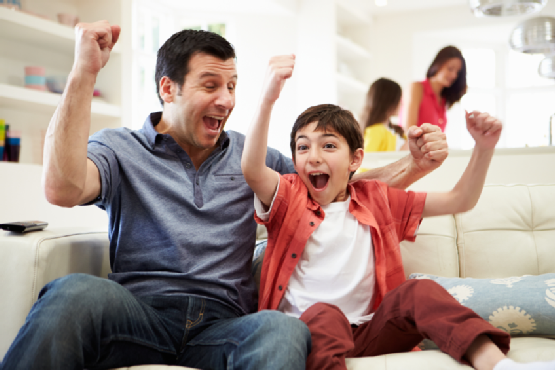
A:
0,228,110,358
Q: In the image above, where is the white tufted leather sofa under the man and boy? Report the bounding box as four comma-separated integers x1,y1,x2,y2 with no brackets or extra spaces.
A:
0,185,555,370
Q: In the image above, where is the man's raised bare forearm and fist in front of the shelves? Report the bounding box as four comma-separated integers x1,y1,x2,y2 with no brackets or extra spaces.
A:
42,21,120,207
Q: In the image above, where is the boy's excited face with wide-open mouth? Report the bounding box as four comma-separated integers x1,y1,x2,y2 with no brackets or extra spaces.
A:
295,122,364,206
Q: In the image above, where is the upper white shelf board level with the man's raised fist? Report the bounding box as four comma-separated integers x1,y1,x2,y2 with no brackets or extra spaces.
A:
0,7,120,55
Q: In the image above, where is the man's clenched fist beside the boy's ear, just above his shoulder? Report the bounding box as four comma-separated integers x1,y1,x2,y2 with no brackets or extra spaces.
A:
408,123,448,173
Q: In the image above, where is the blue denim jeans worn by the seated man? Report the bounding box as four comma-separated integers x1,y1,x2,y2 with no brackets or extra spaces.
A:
0,274,310,370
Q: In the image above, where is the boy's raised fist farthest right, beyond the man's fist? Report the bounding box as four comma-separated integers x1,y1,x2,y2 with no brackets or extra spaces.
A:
466,111,503,149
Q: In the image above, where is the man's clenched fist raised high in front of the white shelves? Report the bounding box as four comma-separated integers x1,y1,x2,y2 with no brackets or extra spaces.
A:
73,21,121,77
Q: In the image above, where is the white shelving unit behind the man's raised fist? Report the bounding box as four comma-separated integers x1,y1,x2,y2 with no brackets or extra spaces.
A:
0,0,131,164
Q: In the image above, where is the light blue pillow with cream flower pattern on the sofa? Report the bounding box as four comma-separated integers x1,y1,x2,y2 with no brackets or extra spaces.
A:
409,274,555,347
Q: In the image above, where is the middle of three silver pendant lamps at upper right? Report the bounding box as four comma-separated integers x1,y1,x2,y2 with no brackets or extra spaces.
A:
509,17,555,54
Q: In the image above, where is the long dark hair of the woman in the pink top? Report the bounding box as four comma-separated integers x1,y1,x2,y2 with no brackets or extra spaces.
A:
426,46,467,108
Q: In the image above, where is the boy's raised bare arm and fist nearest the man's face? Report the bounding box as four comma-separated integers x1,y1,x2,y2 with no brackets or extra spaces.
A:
241,55,295,206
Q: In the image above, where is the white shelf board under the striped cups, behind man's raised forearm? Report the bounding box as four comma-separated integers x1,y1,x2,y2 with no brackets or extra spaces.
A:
0,84,121,118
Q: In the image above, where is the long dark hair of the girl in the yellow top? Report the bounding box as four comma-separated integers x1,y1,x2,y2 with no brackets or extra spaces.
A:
360,78,405,138
